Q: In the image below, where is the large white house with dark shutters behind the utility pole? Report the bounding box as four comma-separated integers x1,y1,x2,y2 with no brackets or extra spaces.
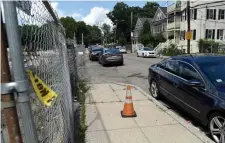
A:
178,0,225,53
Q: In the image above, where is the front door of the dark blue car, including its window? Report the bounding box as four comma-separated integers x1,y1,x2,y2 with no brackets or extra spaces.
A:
179,61,210,118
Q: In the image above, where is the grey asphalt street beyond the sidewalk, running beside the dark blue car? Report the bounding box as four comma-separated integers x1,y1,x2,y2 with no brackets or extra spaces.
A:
86,53,215,142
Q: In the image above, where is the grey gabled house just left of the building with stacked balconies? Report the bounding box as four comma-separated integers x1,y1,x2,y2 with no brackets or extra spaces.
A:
151,7,167,38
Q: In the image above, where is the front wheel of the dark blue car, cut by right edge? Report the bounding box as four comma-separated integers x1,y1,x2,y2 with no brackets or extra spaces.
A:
208,113,225,143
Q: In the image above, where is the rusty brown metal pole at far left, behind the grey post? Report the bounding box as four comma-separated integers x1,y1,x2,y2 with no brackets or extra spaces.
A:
1,12,22,143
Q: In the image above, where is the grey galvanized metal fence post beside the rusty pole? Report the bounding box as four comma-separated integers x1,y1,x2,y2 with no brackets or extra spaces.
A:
3,1,38,143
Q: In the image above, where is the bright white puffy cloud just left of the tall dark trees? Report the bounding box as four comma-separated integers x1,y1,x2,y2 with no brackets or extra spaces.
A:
82,7,112,27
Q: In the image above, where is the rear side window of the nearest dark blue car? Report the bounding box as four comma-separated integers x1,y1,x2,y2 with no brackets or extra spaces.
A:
160,61,180,76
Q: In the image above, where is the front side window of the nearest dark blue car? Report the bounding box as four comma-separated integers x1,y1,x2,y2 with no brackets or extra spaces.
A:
179,62,201,80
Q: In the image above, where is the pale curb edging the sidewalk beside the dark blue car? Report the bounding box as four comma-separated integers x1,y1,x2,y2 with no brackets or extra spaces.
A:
112,82,212,143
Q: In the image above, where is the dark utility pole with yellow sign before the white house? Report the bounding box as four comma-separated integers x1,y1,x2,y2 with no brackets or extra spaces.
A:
187,0,191,54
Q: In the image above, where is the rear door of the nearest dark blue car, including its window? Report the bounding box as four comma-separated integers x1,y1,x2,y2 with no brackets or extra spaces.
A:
157,60,183,105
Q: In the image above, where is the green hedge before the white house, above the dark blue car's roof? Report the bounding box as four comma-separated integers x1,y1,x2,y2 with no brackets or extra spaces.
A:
198,39,219,53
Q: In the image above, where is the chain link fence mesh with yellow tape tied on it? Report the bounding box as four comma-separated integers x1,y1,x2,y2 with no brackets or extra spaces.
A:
1,1,77,143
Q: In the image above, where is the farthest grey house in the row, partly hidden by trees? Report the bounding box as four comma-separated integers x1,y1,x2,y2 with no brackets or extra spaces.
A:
133,18,152,44
